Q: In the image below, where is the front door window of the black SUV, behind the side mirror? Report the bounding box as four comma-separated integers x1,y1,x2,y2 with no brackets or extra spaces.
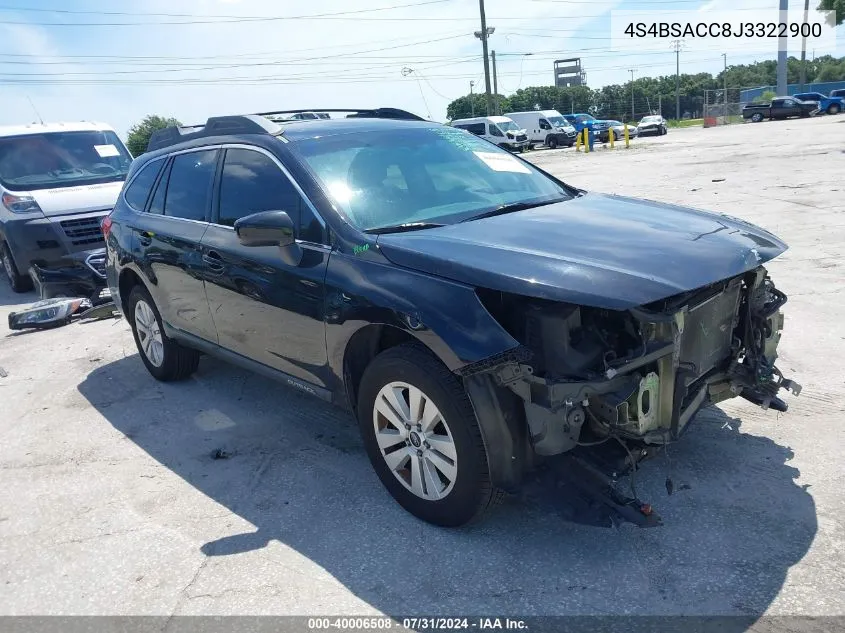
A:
216,149,324,243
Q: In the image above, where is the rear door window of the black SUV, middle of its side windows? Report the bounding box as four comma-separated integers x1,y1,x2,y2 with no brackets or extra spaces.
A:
164,149,217,221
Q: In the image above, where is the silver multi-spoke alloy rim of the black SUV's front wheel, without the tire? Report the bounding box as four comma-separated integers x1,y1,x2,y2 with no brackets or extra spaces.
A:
373,382,458,501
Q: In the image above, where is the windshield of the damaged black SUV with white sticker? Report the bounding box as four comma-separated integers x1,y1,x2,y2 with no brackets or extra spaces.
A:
293,126,572,230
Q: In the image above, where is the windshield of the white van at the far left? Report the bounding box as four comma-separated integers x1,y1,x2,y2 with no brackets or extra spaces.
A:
0,131,132,191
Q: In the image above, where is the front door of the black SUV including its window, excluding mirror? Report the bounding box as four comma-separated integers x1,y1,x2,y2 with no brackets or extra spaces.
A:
202,146,330,386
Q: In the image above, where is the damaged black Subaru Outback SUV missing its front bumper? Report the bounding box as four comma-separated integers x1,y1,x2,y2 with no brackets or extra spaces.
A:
103,109,799,526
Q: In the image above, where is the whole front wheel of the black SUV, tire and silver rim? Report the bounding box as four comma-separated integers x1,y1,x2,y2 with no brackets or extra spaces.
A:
358,343,502,527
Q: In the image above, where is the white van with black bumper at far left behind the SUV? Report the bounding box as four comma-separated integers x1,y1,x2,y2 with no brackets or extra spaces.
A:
0,123,132,292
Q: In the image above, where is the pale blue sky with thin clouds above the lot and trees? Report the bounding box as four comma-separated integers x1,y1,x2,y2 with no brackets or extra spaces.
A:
0,0,845,135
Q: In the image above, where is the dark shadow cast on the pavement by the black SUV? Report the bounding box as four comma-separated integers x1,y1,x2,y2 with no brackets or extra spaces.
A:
79,355,817,630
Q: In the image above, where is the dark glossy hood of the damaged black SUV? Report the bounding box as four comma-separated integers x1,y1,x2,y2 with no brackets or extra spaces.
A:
378,194,787,310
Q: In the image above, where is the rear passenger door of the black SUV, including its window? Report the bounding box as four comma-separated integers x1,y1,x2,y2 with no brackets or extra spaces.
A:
132,148,220,342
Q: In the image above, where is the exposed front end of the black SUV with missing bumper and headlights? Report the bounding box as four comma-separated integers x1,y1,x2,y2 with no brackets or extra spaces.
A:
479,267,801,455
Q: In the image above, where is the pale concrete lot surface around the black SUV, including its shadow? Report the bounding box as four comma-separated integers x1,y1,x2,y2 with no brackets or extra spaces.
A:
0,115,845,616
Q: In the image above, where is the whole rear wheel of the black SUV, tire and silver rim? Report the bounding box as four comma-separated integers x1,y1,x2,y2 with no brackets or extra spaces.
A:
126,285,200,382
